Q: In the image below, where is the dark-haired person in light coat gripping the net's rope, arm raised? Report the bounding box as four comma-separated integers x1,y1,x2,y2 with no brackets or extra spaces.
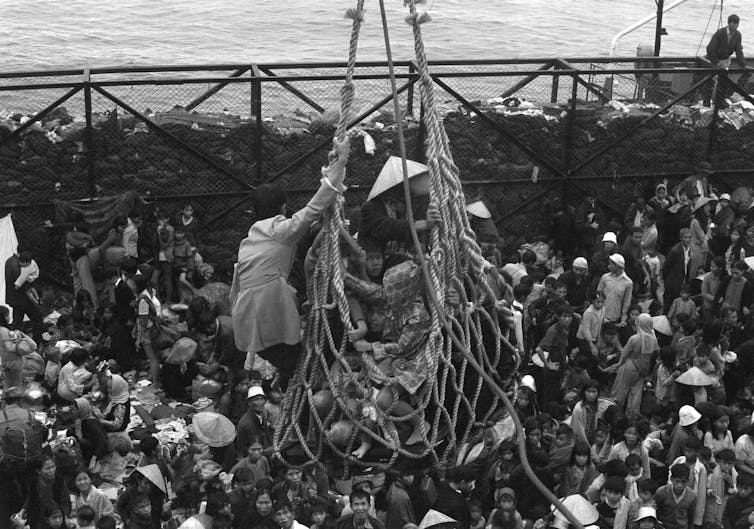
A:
230,140,349,390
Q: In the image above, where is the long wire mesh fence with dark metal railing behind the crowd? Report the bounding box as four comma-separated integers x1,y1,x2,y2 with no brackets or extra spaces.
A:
0,58,754,288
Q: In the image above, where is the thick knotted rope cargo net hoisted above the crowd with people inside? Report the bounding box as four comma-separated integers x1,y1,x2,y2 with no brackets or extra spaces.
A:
274,0,515,477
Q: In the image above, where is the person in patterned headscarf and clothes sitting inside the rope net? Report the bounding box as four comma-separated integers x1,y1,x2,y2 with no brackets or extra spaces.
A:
354,261,431,444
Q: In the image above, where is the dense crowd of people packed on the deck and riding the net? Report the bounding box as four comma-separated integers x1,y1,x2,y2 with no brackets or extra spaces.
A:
0,138,754,529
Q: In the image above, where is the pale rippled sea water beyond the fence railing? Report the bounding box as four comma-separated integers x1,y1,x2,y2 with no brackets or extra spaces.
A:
0,0,754,72
